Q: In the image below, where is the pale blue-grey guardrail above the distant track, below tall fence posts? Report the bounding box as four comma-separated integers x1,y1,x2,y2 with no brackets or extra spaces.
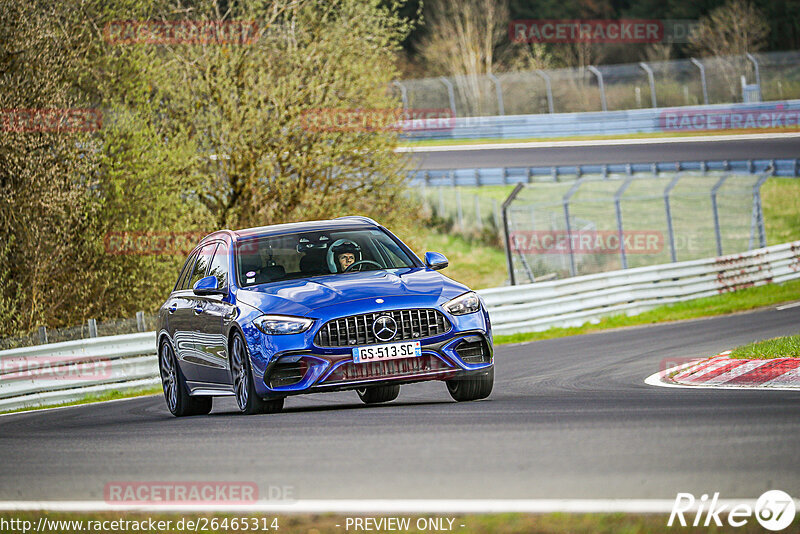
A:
403,100,800,141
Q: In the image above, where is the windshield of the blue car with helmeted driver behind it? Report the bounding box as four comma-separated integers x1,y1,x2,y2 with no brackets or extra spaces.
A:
236,229,415,287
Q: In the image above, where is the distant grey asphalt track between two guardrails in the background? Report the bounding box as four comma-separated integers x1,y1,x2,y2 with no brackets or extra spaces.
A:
410,137,800,169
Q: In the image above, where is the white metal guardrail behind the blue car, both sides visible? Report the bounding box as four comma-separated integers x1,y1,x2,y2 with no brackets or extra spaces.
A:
0,241,800,411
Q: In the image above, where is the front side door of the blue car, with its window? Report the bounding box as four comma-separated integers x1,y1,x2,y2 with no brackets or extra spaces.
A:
192,242,233,386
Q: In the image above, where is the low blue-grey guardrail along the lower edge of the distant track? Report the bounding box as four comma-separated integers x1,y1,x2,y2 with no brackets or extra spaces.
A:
408,158,800,187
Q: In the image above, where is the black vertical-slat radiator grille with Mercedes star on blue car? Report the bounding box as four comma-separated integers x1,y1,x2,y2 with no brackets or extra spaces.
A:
314,309,450,347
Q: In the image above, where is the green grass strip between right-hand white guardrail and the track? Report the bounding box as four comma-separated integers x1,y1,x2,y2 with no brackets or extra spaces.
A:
494,280,800,344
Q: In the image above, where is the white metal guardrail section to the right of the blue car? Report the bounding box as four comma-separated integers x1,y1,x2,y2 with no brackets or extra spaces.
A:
478,241,800,335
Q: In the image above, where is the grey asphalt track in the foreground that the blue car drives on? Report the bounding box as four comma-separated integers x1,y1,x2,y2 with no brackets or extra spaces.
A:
0,307,800,501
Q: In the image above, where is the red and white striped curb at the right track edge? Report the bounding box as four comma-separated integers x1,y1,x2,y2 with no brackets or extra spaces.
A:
645,351,800,390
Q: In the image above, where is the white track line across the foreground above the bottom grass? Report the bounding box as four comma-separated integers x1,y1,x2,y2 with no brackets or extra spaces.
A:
0,499,768,514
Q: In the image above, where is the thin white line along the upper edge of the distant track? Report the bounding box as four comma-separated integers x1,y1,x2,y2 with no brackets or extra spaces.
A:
394,132,800,153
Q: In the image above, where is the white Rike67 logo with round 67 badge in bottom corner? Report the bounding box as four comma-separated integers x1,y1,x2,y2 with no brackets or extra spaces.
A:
667,490,795,532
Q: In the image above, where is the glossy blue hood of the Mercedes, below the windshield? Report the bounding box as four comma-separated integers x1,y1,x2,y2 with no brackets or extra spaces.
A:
236,268,468,315
